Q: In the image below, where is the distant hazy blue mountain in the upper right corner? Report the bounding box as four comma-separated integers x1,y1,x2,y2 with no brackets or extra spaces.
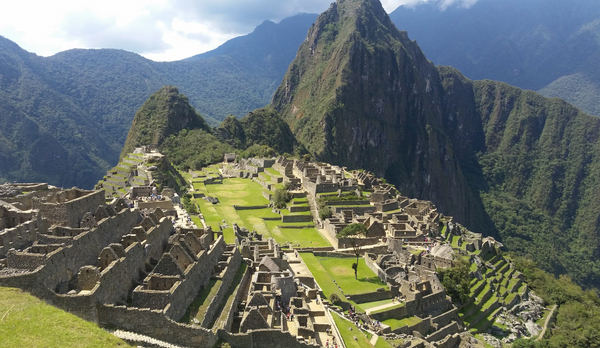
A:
390,0,600,115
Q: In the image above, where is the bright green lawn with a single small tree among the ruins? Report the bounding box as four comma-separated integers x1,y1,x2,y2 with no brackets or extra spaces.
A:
309,256,387,295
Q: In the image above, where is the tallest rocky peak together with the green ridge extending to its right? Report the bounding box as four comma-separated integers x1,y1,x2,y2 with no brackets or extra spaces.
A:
272,0,600,287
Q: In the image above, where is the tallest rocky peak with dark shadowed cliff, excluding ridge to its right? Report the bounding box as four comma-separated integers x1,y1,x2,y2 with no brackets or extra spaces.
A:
273,0,481,225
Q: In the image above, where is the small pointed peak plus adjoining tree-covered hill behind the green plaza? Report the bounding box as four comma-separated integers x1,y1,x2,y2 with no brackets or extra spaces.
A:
121,86,303,170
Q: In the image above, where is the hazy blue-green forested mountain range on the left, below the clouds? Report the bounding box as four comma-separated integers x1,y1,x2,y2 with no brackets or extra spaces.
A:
0,15,316,188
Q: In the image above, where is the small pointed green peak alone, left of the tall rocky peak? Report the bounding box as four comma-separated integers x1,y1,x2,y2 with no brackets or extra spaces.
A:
121,86,210,158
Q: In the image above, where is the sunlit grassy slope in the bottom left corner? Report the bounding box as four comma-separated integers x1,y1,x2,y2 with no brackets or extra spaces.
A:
0,288,129,348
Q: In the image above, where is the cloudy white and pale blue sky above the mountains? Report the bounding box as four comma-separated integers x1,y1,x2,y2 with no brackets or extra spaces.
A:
0,0,477,61
